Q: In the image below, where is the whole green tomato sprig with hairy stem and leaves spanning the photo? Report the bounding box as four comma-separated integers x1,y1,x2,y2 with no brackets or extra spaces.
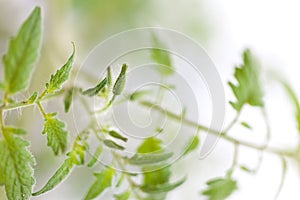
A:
0,7,300,200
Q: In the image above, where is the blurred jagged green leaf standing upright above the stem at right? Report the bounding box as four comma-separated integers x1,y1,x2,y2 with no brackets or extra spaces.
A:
229,50,264,112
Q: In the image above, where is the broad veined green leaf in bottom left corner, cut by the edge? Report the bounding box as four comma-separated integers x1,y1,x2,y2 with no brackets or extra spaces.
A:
0,129,35,200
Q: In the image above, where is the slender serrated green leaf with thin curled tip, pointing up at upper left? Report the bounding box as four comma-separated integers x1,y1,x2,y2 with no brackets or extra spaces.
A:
46,43,75,94
